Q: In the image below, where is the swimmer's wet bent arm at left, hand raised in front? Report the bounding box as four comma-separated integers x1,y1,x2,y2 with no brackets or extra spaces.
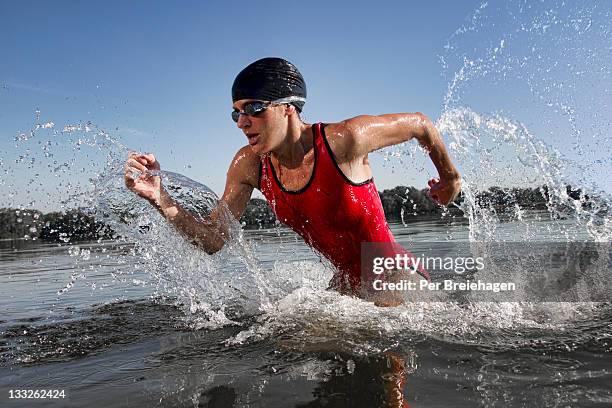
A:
126,148,259,254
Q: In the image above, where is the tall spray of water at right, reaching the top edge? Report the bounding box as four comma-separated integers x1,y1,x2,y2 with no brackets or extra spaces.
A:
420,0,612,326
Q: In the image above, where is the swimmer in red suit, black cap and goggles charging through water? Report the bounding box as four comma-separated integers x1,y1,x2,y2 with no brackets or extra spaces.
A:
125,58,461,305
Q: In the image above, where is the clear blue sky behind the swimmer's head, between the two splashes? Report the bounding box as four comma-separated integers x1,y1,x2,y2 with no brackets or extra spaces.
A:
0,0,609,210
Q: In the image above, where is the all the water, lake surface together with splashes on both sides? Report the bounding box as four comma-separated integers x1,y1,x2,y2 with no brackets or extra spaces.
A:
0,1,612,407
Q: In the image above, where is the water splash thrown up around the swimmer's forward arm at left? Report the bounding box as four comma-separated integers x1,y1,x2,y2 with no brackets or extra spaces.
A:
0,117,278,327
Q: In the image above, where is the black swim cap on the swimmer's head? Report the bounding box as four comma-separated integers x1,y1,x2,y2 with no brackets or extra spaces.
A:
232,57,306,112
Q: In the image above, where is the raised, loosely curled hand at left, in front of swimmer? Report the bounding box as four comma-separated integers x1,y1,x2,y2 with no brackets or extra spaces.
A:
124,152,162,206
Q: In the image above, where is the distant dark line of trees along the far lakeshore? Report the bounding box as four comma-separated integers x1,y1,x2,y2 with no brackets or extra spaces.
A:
0,186,607,242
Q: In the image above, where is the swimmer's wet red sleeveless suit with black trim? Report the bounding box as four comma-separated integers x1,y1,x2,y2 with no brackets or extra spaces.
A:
259,123,426,290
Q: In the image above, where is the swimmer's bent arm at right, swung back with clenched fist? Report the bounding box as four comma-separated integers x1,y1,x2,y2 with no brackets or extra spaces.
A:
336,113,460,205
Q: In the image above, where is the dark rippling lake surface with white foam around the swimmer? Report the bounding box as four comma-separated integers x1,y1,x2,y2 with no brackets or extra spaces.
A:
0,220,612,407
